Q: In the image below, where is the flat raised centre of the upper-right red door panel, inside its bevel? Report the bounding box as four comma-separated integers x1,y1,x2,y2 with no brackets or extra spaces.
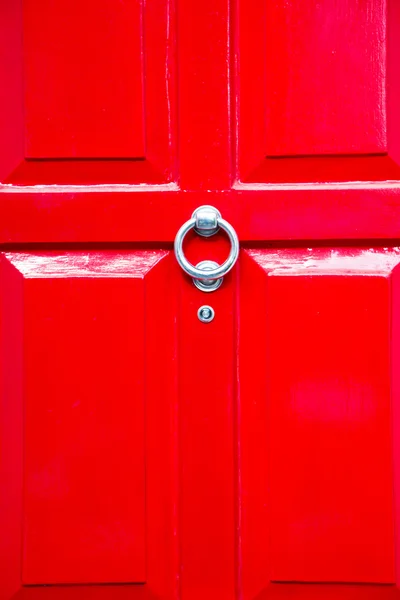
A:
265,0,386,156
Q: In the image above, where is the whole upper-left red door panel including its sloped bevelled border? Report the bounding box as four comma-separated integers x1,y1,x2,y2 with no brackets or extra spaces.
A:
0,0,177,185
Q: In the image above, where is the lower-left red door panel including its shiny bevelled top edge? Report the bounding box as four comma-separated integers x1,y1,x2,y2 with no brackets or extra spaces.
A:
0,251,178,591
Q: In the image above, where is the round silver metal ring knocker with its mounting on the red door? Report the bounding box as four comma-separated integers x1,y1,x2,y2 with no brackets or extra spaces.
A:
174,206,239,292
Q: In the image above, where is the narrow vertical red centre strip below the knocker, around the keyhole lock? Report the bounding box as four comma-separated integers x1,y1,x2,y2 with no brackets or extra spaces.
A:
176,262,237,600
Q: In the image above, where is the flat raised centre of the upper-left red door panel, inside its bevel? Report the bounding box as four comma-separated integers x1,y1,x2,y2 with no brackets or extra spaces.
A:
23,0,144,158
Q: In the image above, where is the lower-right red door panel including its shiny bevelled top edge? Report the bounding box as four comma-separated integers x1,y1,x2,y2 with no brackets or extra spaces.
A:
239,249,400,584
